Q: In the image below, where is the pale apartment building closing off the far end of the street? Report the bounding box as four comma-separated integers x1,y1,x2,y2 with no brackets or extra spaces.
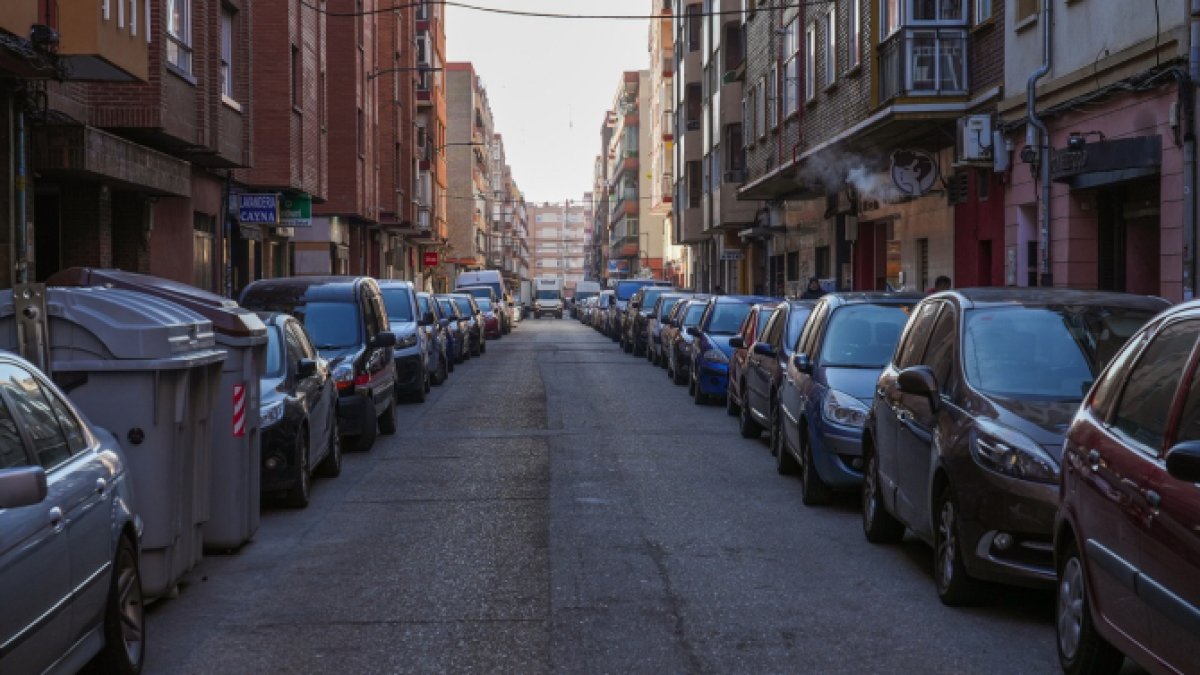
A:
528,195,593,297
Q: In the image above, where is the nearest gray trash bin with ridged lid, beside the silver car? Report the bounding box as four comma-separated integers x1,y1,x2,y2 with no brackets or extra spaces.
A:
0,283,226,597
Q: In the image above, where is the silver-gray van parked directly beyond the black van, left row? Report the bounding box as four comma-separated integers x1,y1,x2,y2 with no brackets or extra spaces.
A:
379,280,434,402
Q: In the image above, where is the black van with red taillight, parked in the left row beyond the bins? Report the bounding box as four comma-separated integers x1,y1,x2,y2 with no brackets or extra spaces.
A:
240,276,396,450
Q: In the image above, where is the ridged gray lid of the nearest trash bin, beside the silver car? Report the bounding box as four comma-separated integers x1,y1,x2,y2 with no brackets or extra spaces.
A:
0,288,216,364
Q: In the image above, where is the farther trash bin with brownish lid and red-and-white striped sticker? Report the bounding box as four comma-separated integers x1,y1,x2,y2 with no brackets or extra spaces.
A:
47,267,266,550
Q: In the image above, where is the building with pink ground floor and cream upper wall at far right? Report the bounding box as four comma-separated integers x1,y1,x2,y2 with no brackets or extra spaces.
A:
996,0,1196,301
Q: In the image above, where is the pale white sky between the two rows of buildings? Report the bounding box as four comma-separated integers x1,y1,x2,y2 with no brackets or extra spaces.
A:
445,0,661,202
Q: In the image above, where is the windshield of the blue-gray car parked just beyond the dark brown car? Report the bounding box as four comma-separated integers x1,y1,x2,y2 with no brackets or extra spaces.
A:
821,304,912,368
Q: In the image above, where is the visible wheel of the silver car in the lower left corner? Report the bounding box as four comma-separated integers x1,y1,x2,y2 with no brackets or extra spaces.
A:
96,536,146,675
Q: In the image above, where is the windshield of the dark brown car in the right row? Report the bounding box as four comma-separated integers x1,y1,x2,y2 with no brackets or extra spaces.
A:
962,305,1153,401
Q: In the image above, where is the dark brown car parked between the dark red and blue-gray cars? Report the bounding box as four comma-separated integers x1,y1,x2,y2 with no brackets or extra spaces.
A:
863,288,1168,605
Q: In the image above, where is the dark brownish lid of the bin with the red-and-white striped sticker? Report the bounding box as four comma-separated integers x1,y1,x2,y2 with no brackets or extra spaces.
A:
46,267,266,344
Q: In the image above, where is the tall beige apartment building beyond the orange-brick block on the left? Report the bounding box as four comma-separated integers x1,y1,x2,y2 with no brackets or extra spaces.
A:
445,62,494,279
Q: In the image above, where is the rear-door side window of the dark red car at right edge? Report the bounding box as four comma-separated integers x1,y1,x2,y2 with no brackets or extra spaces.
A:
1112,321,1200,452
